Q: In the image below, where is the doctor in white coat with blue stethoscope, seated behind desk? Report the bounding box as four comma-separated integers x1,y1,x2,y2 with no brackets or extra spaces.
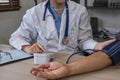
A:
9,0,113,54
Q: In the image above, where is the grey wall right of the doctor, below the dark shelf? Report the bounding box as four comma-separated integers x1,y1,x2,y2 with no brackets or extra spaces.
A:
80,0,120,32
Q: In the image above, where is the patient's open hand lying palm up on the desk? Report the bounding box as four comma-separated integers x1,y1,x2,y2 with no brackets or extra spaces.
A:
30,62,70,80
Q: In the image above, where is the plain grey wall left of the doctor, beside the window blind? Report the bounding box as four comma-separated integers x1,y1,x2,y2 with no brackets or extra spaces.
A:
0,0,41,44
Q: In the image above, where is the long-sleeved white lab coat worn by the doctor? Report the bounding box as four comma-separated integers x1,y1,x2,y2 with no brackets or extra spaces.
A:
9,1,97,53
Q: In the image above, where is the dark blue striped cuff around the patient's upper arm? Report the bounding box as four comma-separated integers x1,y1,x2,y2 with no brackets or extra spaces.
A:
102,40,120,65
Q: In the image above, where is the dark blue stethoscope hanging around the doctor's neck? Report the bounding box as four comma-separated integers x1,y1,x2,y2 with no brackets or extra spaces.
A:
43,0,69,45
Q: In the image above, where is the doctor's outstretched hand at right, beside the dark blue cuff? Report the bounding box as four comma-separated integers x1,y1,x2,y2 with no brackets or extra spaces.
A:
94,39,116,50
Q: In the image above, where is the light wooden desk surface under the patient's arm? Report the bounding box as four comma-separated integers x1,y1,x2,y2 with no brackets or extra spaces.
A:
0,44,120,80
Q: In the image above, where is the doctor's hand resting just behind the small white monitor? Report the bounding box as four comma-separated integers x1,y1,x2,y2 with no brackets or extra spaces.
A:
22,43,46,54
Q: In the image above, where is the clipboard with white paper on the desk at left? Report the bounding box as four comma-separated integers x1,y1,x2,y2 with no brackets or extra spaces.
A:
0,49,33,66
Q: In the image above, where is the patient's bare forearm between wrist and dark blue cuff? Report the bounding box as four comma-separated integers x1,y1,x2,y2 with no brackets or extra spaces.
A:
68,52,112,76
